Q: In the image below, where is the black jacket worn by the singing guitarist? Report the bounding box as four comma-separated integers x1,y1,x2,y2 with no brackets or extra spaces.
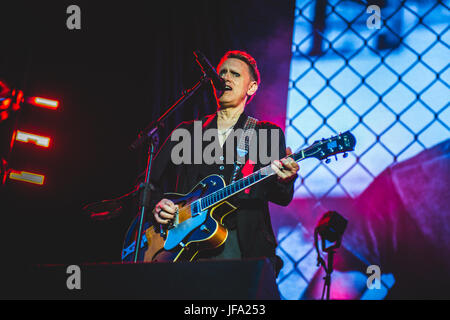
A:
151,112,294,269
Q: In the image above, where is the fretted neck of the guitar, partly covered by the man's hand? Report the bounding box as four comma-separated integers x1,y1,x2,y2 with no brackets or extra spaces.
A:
200,150,305,210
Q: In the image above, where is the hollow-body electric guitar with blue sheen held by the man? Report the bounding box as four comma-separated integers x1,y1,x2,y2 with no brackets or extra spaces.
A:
122,131,356,262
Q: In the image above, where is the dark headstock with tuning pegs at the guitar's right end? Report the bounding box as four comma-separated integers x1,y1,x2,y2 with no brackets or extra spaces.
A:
304,131,356,160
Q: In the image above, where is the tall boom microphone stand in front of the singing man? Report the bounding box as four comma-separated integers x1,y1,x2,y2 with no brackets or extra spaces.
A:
129,73,210,263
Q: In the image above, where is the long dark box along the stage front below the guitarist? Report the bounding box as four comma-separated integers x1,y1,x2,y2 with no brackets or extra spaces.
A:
22,259,280,300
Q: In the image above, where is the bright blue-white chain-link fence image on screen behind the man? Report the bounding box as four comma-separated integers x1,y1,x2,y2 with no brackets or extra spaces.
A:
277,0,450,300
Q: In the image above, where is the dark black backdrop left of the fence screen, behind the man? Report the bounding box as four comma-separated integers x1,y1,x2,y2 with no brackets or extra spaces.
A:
0,1,294,277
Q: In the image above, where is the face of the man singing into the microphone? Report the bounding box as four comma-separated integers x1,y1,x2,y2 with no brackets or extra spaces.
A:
216,58,258,108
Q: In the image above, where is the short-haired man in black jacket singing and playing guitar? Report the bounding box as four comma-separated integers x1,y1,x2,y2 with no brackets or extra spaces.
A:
152,51,299,275
